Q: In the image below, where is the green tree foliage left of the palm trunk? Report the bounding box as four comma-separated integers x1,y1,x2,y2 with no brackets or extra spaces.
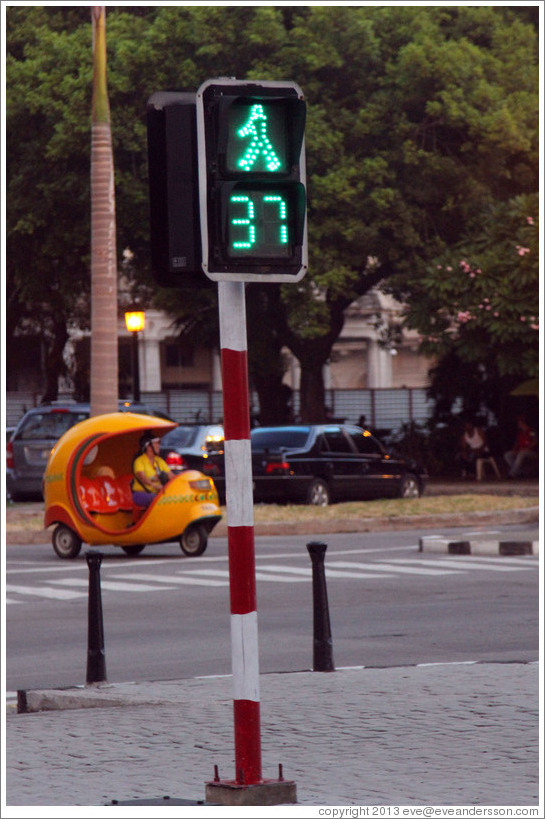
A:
6,7,91,399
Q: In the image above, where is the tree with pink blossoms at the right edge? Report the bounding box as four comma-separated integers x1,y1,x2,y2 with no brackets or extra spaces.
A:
406,195,539,383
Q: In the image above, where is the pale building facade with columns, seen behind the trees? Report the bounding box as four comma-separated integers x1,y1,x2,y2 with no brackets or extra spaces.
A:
6,290,433,398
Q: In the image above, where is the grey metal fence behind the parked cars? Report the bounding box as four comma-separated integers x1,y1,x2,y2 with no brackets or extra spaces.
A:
6,387,433,430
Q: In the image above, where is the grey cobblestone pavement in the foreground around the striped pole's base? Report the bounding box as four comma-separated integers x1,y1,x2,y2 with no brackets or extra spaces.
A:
2,662,543,816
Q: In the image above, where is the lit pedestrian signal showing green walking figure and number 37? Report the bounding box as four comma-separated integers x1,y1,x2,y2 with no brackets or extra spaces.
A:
197,79,308,282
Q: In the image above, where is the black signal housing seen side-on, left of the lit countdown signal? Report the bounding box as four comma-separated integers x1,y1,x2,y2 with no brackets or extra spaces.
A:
147,91,205,287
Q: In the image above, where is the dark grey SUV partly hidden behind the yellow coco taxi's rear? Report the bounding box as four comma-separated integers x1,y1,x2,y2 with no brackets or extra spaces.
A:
6,401,171,501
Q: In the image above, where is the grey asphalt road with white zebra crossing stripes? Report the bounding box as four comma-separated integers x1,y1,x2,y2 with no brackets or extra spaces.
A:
6,527,538,691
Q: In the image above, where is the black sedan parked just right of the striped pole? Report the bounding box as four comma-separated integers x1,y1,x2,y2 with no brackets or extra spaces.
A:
250,424,427,506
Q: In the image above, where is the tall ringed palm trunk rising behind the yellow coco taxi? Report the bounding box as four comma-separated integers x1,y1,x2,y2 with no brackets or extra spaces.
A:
91,6,118,415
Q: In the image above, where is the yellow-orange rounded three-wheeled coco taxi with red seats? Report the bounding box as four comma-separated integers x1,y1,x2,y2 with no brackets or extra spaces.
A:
44,412,221,558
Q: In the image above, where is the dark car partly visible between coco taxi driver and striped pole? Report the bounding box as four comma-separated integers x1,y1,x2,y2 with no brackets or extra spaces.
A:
160,424,225,503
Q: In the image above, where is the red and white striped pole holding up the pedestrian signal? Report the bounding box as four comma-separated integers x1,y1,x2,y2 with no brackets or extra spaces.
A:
218,281,262,785
